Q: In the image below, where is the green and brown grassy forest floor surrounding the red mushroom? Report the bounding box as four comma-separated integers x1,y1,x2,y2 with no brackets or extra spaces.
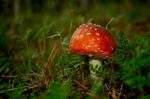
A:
0,3,150,99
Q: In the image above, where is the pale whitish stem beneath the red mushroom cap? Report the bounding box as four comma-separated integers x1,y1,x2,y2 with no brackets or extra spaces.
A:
89,59,103,85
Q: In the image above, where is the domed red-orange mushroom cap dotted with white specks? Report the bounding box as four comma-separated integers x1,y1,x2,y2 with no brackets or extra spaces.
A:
69,23,116,58
